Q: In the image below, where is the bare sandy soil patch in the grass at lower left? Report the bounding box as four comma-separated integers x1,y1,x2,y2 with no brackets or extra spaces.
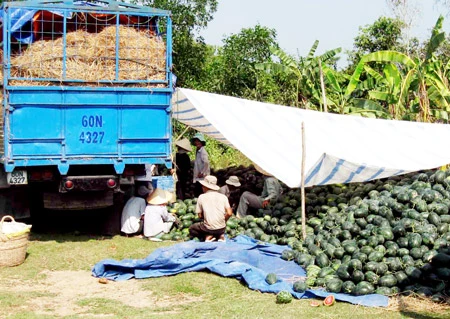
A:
0,271,200,317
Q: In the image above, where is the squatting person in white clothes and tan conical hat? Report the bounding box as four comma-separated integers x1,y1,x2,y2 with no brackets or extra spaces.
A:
144,188,176,241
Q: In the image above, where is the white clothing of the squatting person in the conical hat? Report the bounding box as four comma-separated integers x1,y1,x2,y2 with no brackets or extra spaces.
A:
144,205,175,237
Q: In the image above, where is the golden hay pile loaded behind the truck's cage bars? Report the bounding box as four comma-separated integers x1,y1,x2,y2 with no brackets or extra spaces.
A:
6,26,166,85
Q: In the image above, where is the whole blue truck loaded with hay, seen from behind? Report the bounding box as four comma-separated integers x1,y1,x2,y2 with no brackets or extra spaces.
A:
0,0,174,232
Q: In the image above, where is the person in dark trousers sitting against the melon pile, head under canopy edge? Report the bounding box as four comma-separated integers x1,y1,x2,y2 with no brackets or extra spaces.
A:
236,164,283,218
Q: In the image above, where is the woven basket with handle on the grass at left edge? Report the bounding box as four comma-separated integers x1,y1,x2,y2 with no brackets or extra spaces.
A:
0,215,29,266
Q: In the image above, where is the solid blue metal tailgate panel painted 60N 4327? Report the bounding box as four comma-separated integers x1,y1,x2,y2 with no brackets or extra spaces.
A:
4,87,171,173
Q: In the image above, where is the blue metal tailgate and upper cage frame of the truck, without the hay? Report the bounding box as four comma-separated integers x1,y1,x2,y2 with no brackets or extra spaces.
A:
2,1,172,174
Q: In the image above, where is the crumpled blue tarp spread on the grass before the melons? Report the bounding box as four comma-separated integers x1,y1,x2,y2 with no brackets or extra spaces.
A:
92,235,388,307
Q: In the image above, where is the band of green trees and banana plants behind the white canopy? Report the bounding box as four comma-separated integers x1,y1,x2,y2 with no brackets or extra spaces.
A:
143,0,450,167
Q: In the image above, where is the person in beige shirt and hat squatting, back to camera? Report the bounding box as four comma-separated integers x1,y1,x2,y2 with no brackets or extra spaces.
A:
189,175,233,241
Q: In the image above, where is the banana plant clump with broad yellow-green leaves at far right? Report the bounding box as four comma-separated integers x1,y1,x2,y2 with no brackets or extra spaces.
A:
346,16,450,122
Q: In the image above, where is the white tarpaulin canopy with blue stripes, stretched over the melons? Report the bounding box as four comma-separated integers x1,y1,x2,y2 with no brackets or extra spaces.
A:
172,89,450,187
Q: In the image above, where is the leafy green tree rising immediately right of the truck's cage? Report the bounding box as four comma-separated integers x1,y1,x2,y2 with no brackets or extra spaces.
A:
134,0,218,87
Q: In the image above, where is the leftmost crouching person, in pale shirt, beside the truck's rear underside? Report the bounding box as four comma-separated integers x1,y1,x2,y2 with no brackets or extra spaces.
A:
120,186,151,236
